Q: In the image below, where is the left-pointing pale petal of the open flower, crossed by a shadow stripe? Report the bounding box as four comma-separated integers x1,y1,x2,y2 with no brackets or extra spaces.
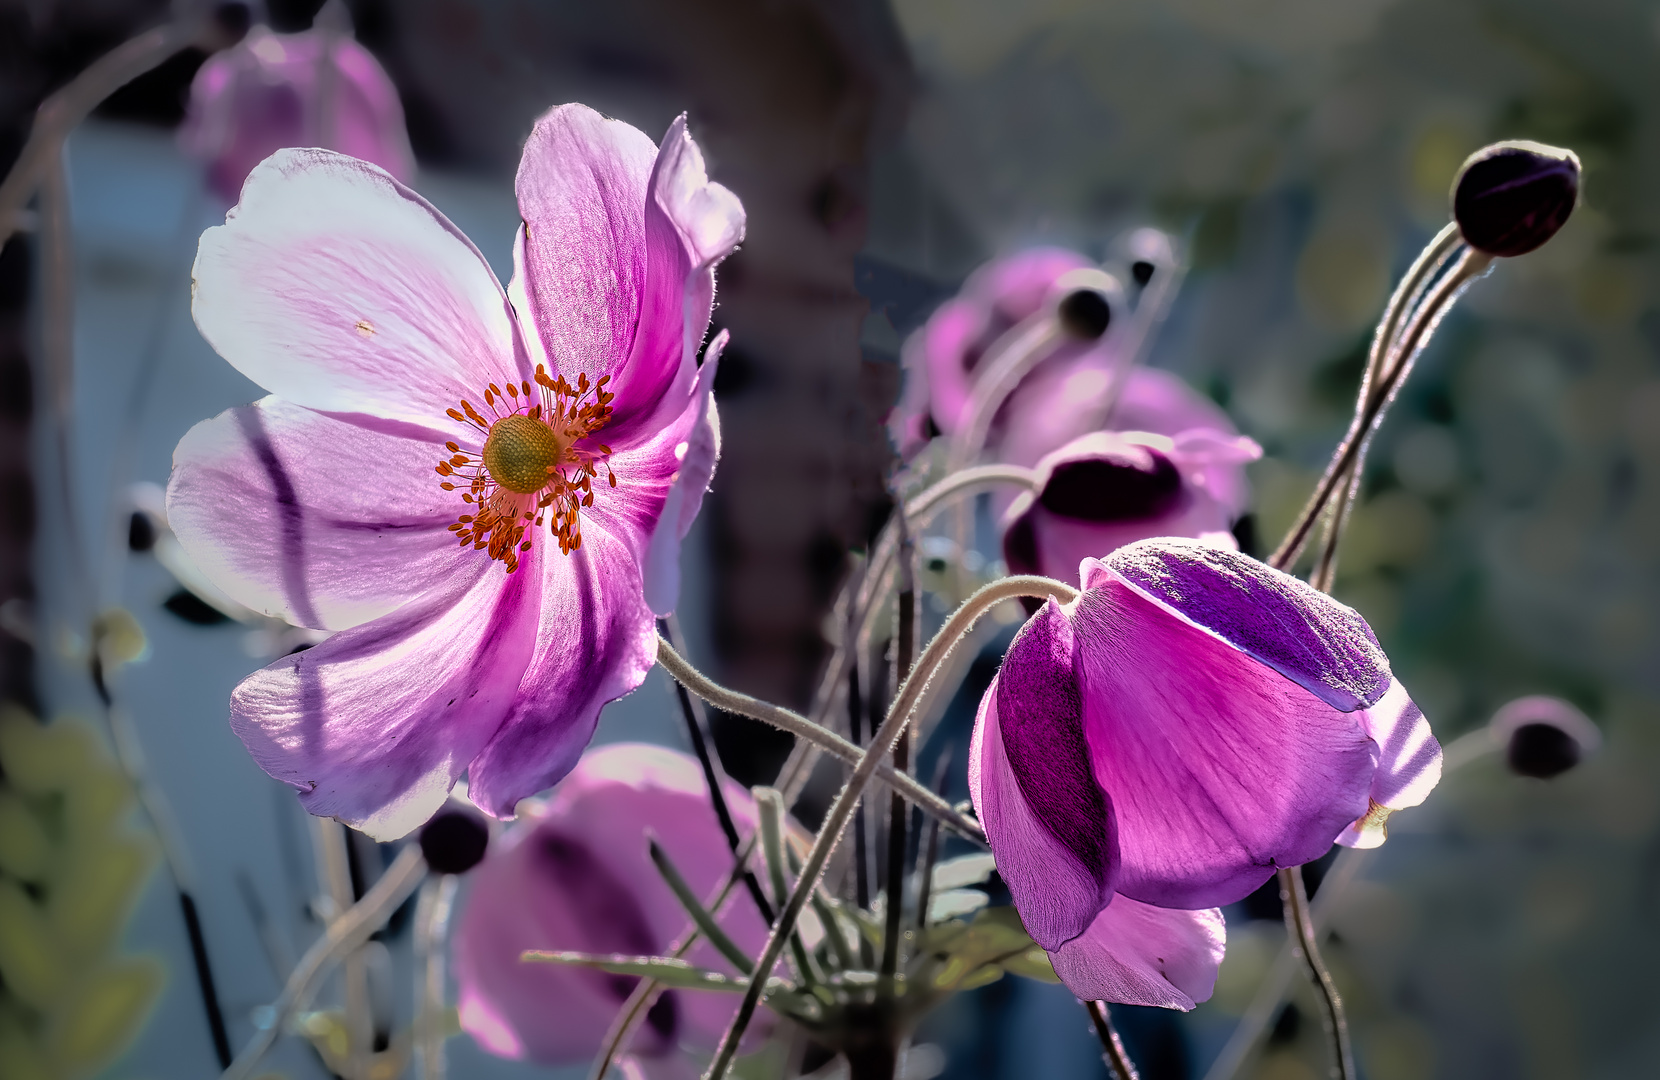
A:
168,396,461,630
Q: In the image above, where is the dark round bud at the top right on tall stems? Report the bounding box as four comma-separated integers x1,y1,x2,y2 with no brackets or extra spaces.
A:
1453,141,1579,255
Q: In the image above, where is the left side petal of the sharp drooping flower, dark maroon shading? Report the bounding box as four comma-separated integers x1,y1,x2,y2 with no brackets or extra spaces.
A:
968,601,1116,949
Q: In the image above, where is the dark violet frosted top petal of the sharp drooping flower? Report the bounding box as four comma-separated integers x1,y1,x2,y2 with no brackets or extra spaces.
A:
1108,539,1393,712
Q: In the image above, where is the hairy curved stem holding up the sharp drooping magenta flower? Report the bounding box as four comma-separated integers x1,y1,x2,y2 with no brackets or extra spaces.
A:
700,576,1077,1080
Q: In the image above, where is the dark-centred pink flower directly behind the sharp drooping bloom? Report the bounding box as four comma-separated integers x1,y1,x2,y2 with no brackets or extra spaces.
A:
1003,428,1262,586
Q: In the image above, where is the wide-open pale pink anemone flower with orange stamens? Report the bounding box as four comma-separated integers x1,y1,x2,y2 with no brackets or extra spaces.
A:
168,105,744,838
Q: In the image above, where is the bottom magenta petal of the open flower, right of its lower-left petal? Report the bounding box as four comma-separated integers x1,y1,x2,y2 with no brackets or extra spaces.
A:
468,520,657,818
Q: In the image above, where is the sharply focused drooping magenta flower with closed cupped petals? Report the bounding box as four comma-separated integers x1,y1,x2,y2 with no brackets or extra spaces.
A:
969,539,1441,1009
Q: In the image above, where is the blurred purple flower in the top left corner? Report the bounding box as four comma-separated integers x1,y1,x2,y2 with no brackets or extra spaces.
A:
179,27,415,202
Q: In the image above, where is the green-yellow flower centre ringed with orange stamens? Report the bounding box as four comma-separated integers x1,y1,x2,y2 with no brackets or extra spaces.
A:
438,363,618,574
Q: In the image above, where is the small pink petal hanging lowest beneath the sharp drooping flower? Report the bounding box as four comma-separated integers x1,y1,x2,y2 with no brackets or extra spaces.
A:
1049,896,1227,1012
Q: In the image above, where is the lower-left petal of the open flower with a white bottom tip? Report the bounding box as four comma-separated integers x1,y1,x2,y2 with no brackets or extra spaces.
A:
231,546,544,839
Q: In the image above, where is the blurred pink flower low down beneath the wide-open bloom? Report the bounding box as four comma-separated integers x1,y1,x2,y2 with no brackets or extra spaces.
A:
455,743,767,1072
